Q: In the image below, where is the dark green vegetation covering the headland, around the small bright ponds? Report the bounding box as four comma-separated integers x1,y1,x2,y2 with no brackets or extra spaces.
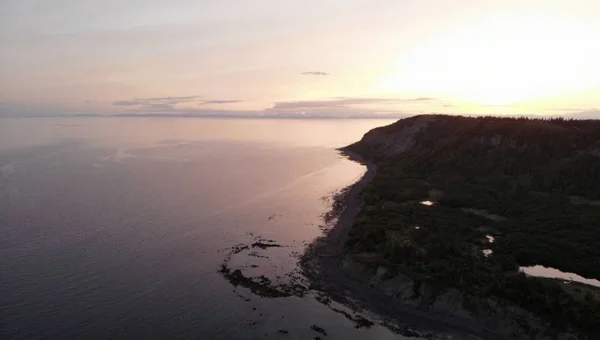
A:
346,116,600,336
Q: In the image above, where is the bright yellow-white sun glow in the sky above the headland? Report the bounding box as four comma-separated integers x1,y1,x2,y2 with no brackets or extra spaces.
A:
382,15,600,105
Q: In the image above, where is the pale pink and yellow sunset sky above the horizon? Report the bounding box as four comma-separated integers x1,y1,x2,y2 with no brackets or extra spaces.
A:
0,0,600,118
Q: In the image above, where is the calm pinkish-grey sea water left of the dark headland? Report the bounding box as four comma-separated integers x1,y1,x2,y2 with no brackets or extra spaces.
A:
0,118,424,339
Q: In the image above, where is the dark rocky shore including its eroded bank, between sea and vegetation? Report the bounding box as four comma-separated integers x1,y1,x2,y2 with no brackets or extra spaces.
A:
301,149,577,340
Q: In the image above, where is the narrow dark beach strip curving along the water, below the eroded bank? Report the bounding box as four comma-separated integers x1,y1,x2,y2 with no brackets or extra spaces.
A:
301,148,505,340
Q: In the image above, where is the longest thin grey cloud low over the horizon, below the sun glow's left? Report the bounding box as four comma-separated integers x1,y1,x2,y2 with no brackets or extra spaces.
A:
272,97,436,110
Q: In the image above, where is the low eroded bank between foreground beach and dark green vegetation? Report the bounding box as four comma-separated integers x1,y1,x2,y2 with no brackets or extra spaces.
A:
343,256,580,340
